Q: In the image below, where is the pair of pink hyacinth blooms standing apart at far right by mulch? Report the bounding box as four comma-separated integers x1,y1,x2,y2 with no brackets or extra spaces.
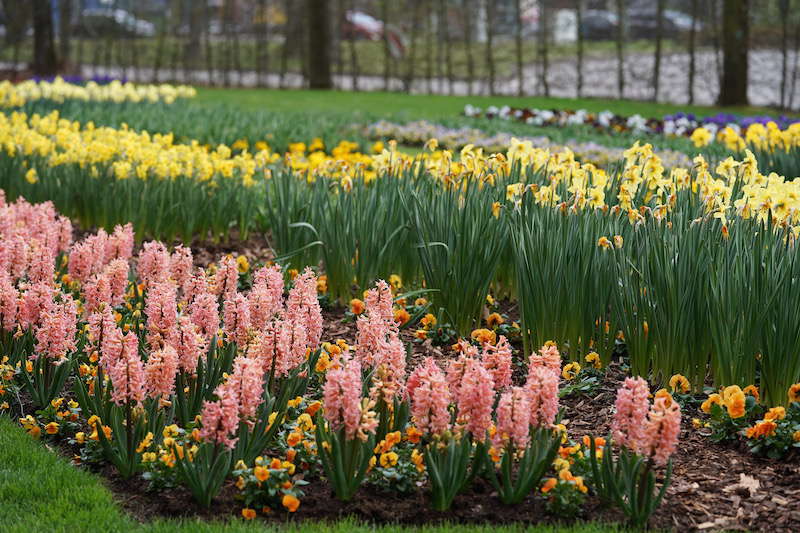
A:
611,377,681,465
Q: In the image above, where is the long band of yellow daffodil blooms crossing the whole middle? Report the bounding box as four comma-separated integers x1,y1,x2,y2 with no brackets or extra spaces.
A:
0,111,800,230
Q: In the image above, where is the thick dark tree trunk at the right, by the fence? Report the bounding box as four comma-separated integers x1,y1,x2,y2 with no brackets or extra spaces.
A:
719,0,750,106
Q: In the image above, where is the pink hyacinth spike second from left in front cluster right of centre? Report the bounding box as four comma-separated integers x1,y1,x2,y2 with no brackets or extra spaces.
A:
456,359,495,441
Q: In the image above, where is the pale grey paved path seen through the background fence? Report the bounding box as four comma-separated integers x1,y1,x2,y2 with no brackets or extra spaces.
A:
7,50,800,109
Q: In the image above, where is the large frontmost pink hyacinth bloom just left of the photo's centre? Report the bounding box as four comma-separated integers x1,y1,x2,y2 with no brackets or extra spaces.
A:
322,353,361,440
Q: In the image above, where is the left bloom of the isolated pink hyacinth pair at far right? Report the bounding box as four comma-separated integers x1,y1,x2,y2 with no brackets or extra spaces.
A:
611,377,650,453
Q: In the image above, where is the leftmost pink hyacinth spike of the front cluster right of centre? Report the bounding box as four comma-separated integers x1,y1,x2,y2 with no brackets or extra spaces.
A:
407,357,451,435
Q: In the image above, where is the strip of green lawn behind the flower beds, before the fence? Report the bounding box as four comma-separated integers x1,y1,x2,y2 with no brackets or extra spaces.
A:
196,88,776,121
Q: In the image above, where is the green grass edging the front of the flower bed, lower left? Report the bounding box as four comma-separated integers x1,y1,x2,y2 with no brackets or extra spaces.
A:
0,416,618,533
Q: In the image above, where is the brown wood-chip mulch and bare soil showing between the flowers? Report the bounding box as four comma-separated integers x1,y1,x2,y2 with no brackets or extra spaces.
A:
20,237,800,532
